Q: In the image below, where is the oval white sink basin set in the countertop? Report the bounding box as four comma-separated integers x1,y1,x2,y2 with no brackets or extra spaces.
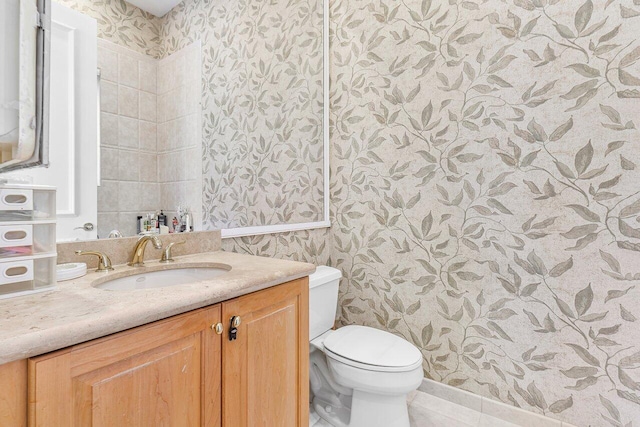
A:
95,267,230,291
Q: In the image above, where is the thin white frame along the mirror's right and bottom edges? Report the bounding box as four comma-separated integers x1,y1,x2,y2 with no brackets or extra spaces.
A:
221,0,331,239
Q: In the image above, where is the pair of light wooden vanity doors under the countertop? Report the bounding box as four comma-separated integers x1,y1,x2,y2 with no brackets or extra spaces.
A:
22,278,309,427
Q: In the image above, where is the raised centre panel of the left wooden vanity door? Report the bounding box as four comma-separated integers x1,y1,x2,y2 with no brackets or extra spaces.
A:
73,335,201,427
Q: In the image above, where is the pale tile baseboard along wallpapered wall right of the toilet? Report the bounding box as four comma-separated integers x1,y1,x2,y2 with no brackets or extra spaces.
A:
418,378,576,427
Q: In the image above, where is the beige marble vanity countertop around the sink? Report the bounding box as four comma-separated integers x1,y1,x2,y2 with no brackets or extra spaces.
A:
0,251,315,364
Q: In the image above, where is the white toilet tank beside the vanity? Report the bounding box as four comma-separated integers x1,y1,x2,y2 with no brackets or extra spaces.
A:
309,265,342,341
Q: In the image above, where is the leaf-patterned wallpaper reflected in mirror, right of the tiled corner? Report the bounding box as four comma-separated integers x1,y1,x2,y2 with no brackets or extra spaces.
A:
162,0,323,228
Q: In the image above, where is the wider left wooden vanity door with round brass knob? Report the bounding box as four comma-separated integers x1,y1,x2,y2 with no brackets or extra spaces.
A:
29,305,222,427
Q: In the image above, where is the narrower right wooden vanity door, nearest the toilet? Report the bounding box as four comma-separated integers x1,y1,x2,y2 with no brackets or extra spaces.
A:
222,278,309,427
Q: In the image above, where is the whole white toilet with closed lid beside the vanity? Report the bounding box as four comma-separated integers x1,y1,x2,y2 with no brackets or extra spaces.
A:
309,266,423,427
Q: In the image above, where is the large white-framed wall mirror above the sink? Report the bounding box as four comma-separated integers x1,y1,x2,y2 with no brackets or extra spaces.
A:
5,0,329,240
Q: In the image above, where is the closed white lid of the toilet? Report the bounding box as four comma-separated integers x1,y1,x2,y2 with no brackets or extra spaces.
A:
323,325,422,368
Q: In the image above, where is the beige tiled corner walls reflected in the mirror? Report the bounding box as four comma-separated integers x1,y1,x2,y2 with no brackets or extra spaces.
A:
97,40,202,241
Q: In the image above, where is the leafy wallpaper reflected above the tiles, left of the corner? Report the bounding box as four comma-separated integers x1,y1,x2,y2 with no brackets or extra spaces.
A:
54,0,161,58
